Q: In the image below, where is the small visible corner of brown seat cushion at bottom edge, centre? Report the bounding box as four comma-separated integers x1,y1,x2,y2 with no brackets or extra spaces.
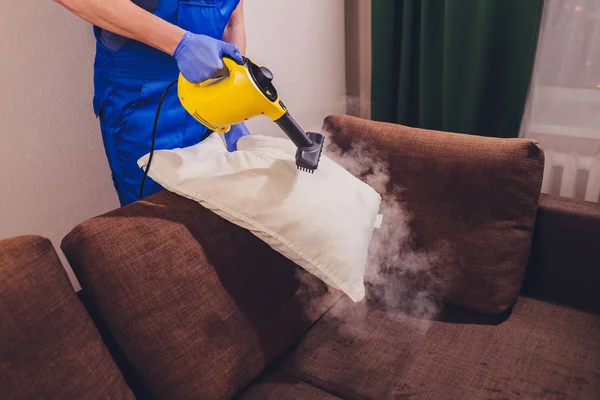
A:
239,372,339,400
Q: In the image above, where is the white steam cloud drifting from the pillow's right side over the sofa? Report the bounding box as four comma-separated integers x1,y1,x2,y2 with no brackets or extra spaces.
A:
292,124,450,336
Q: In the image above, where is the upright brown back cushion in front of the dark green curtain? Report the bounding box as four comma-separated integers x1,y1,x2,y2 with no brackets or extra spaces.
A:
324,116,544,314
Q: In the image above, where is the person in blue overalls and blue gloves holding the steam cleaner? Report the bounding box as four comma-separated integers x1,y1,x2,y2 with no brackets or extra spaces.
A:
55,0,249,206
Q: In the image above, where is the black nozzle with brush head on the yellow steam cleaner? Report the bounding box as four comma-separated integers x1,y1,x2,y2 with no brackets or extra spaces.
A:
275,112,325,173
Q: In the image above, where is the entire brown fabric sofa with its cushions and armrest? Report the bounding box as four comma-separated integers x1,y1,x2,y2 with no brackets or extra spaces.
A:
0,116,600,399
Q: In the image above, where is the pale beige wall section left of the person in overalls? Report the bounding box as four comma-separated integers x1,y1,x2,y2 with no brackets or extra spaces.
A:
0,0,118,288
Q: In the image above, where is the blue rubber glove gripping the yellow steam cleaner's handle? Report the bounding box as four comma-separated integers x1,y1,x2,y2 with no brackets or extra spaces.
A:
173,32,242,83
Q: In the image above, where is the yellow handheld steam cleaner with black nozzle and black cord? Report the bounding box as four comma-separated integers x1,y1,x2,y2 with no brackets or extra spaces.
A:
140,56,325,199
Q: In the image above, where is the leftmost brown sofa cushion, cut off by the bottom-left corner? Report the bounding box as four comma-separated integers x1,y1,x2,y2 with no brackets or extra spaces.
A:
0,236,133,399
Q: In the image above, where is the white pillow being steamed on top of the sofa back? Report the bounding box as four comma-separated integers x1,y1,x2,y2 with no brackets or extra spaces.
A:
138,134,381,302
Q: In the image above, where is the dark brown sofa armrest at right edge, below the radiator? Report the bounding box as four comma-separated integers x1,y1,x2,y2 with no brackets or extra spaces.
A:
523,195,600,313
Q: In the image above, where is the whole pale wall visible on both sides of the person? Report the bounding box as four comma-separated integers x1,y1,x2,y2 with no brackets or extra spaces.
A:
0,0,345,288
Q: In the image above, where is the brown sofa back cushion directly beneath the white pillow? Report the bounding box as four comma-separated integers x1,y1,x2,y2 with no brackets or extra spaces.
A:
62,191,341,399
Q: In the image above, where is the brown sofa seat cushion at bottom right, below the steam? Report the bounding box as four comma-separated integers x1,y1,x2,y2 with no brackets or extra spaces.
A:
284,297,600,400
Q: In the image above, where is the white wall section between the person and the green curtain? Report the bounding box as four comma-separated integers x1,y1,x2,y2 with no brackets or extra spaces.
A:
245,0,346,135
